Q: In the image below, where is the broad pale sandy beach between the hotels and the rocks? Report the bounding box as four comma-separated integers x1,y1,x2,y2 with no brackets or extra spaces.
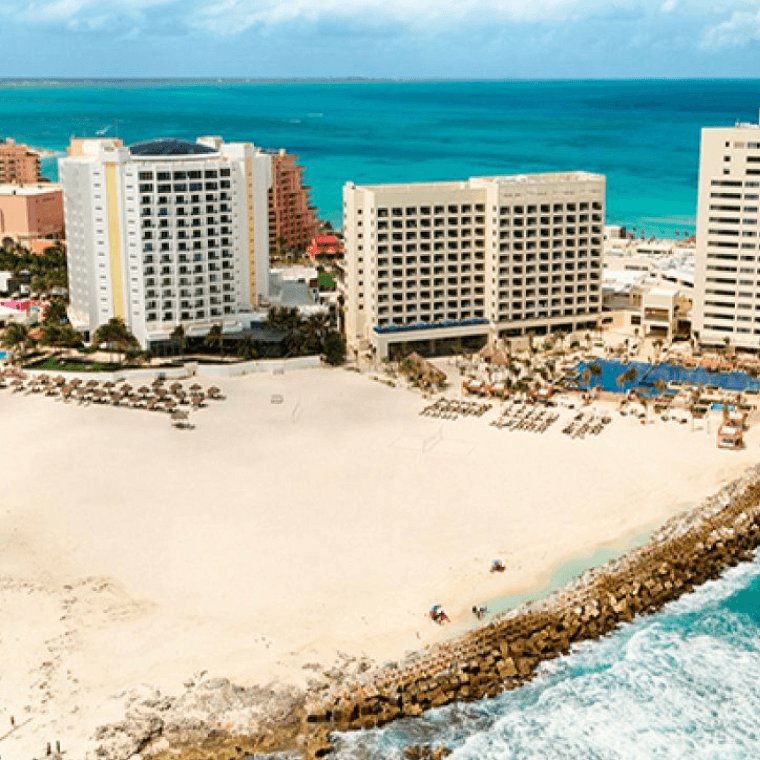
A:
0,370,758,760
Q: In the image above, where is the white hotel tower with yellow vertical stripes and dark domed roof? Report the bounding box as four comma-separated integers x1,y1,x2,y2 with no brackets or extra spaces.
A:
59,137,271,348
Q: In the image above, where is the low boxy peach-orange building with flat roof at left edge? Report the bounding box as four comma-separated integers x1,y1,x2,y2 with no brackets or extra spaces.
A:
0,182,64,243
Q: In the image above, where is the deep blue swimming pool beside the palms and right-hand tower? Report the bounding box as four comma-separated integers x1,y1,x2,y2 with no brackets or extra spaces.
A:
576,359,760,393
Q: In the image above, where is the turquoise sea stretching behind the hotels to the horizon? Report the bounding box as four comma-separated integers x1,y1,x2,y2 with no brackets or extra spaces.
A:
0,80,760,235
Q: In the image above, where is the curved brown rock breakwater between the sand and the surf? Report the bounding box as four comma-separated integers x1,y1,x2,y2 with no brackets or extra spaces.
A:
301,466,760,758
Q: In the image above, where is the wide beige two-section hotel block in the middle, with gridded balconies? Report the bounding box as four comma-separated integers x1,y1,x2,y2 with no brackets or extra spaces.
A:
339,172,605,358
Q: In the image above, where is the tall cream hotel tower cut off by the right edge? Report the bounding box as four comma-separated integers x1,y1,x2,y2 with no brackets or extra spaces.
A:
692,119,760,349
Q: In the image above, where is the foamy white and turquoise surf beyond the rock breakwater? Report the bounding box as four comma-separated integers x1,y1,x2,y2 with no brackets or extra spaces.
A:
335,554,760,760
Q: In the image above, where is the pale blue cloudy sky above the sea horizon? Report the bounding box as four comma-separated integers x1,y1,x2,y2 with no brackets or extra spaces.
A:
0,0,760,78
